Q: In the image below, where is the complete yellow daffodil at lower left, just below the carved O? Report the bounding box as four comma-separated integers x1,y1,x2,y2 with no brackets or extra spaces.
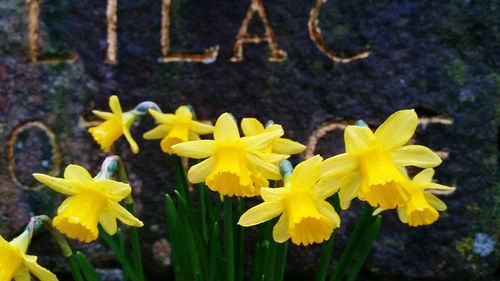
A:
33,165,143,243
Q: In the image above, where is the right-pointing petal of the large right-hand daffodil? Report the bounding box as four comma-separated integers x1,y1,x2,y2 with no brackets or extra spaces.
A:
391,145,442,168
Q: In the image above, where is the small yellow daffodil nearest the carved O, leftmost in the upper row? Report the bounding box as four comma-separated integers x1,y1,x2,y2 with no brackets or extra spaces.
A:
88,96,139,153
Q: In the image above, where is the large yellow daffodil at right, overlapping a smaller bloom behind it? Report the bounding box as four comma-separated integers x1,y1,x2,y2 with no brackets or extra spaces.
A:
322,110,441,209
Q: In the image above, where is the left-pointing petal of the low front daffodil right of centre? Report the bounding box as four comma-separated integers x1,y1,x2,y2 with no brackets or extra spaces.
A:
238,200,285,226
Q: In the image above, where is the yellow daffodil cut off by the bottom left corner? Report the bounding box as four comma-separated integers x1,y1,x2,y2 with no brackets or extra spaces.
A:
0,231,57,281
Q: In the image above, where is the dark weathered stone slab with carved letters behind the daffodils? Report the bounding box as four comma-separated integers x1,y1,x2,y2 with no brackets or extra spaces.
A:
0,0,500,280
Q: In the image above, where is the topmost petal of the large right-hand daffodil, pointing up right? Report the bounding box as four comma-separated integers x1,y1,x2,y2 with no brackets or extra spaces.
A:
375,109,418,150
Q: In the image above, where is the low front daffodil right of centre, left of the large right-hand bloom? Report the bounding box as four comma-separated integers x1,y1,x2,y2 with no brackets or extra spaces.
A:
238,155,340,245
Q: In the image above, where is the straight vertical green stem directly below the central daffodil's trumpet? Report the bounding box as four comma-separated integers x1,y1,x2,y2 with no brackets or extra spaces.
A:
224,196,235,281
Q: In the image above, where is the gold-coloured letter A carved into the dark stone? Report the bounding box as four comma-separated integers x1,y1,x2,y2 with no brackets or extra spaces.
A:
231,0,286,62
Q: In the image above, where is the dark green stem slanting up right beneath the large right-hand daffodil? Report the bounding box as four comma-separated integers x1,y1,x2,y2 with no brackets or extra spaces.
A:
331,203,374,281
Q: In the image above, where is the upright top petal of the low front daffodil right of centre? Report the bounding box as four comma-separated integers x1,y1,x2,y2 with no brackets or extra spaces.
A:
292,155,323,191
